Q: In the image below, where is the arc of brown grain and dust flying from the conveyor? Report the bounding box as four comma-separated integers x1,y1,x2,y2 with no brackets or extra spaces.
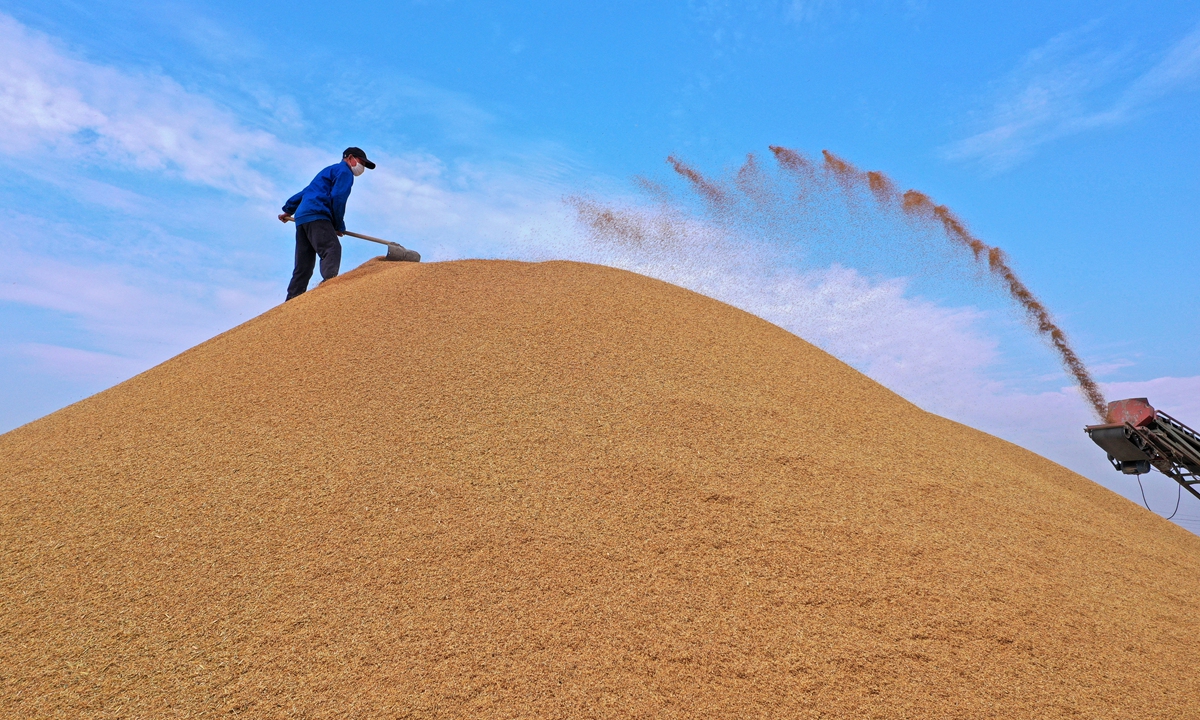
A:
568,145,1106,420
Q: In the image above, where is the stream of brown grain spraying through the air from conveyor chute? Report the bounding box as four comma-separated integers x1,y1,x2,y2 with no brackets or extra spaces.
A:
568,145,1106,420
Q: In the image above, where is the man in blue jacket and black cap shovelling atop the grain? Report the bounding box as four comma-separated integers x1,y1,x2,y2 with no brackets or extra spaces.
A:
280,148,374,300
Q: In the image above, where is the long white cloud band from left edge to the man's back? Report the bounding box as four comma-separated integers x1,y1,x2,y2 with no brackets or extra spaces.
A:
0,13,286,197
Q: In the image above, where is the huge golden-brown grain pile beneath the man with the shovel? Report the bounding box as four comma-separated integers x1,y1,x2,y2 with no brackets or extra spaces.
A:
0,262,1200,718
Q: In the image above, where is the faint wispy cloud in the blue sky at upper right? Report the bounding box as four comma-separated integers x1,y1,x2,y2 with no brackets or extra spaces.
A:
943,24,1200,170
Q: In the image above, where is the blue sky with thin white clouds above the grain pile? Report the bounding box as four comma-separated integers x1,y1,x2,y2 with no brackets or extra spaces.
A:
0,0,1200,529
